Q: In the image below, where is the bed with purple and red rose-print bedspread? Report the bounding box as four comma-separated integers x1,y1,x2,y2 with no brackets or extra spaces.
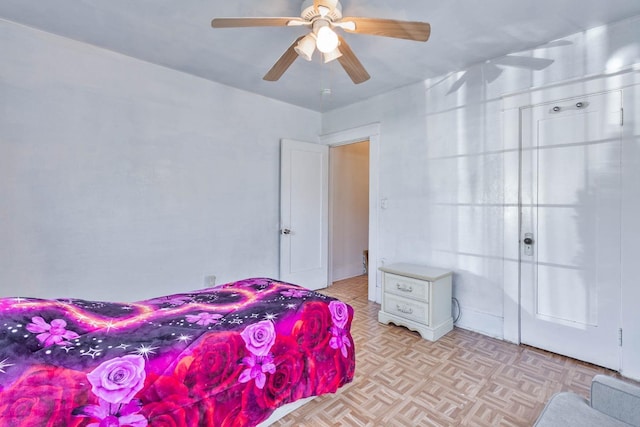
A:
0,278,355,427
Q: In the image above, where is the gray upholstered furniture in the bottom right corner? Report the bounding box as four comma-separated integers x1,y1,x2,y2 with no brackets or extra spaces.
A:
534,375,640,427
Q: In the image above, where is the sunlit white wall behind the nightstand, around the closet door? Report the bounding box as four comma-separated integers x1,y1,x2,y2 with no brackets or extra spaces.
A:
322,17,640,378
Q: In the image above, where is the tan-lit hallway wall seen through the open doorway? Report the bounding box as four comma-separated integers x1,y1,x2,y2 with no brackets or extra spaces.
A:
330,141,369,281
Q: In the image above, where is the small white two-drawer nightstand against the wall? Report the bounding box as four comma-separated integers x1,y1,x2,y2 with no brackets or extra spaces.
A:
378,263,453,341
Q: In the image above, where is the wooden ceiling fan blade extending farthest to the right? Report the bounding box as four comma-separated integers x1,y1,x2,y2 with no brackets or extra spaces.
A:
341,17,431,42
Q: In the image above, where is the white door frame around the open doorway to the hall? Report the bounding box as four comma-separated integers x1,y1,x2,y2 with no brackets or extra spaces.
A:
319,123,382,303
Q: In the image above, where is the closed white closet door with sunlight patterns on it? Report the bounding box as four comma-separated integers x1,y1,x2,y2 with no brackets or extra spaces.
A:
520,92,622,370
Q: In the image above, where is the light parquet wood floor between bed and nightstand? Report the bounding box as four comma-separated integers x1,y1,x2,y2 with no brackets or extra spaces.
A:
273,276,618,427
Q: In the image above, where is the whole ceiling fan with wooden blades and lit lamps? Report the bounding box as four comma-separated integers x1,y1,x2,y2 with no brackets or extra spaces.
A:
211,0,431,84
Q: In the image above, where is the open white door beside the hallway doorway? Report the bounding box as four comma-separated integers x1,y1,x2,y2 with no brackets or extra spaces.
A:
280,140,329,290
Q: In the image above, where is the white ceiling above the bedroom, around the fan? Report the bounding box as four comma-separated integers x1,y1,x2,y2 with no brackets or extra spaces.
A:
0,0,640,111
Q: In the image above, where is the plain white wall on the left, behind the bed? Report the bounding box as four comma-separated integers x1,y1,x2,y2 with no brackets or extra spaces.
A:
0,21,320,300
